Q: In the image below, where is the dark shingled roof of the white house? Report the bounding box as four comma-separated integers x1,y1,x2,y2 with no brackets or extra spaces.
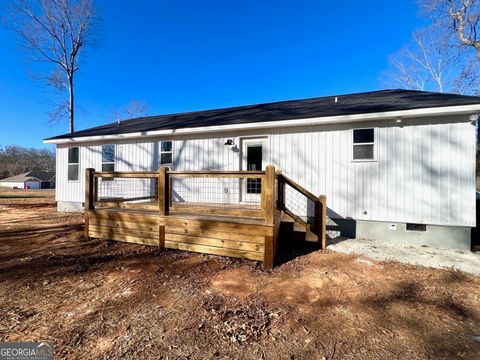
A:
46,89,480,140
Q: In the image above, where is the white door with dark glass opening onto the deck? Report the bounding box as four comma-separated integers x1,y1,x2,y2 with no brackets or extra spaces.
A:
241,138,268,204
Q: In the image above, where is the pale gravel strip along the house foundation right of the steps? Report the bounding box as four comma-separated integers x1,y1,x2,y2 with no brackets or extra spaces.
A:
328,239,480,275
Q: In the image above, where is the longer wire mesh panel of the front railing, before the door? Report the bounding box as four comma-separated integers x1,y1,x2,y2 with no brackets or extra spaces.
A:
170,176,262,208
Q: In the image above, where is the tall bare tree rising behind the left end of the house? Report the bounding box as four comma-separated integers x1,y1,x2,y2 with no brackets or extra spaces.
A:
8,0,98,132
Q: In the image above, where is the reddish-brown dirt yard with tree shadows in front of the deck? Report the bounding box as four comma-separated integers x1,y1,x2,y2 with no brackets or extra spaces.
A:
0,191,480,359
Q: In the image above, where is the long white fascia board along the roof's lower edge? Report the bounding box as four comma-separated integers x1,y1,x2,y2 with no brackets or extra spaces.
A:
43,104,480,144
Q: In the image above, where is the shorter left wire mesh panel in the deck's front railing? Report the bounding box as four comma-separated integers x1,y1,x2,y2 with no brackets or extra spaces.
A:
96,177,158,204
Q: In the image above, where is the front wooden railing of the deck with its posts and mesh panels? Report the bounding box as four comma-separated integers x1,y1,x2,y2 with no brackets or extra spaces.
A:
85,166,276,224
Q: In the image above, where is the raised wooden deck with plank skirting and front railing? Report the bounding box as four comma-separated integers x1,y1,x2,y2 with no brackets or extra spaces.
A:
85,166,326,269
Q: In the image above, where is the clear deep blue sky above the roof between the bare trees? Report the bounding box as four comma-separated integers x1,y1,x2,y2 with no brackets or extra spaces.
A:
0,0,422,147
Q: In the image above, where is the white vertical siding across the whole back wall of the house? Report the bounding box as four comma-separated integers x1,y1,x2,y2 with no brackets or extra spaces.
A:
57,115,475,226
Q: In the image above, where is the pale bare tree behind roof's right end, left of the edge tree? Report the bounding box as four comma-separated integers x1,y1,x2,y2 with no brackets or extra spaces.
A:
382,27,458,92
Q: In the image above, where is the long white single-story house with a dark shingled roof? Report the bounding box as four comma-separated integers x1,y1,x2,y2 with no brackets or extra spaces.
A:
45,90,480,249
